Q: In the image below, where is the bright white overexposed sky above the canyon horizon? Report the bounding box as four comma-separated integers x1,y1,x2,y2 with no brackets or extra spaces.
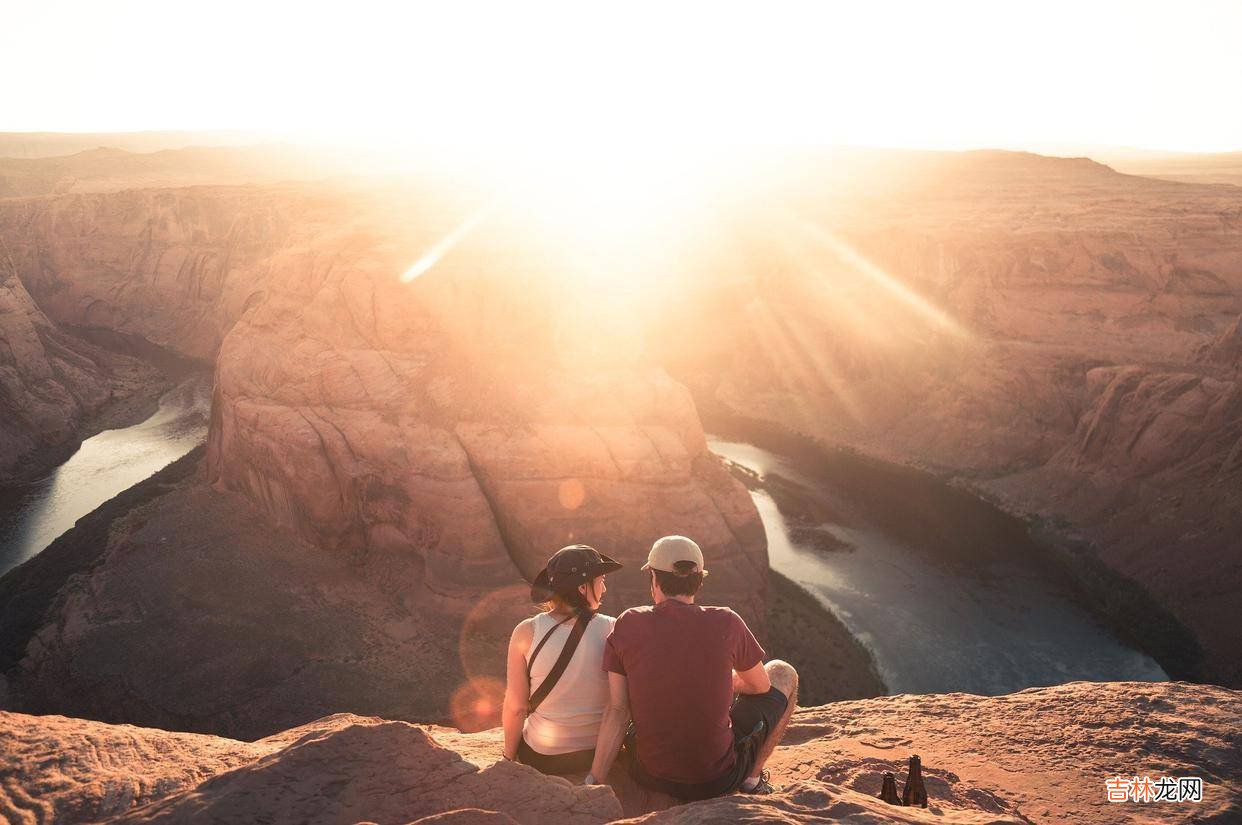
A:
0,0,1242,150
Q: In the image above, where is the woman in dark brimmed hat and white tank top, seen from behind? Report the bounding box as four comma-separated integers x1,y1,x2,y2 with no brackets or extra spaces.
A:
504,544,621,774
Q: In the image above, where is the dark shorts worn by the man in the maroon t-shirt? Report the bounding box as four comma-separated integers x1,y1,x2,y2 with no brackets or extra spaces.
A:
625,686,789,800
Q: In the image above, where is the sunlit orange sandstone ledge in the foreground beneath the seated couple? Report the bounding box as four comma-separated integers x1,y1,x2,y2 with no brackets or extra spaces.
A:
0,682,1242,825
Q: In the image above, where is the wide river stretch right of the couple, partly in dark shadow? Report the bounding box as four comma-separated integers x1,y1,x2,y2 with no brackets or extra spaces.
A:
709,436,1167,696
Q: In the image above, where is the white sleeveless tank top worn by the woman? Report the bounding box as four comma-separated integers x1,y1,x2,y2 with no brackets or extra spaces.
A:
523,613,616,755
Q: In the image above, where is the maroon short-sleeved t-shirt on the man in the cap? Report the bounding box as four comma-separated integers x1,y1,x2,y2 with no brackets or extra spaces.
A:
604,599,764,783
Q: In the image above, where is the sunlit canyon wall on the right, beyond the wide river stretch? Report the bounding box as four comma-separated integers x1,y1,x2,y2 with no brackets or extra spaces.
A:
662,153,1242,685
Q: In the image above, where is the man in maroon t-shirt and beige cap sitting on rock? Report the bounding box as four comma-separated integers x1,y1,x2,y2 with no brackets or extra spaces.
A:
586,536,797,800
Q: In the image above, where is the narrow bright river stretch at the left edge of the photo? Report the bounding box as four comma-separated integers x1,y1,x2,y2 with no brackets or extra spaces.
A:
0,371,211,575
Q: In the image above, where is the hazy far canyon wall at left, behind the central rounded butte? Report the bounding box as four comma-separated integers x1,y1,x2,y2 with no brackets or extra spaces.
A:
0,186,325,359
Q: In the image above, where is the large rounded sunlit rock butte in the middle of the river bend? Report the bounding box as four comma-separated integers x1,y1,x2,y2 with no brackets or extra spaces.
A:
207,188,766,622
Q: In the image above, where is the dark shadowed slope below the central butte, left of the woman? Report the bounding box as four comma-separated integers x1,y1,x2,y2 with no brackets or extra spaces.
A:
0,467,466,738
